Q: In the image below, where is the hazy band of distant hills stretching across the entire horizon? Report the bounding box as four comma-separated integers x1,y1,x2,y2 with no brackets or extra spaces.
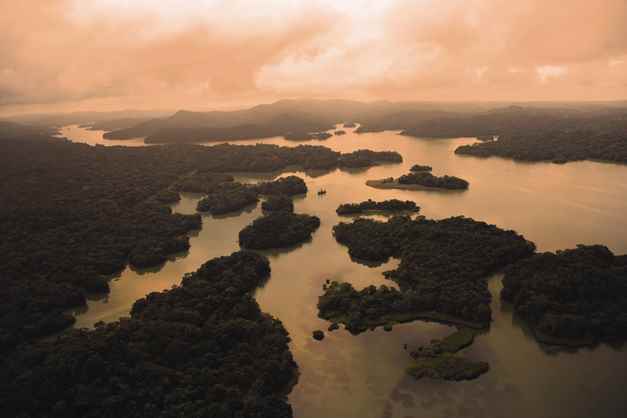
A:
4,100,627,162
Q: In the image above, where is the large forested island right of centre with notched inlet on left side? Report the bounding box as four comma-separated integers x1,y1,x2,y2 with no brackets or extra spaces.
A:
332,216,535,330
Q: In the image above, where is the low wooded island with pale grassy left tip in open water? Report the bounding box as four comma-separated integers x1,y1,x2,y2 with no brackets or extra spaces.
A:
366,167,469,190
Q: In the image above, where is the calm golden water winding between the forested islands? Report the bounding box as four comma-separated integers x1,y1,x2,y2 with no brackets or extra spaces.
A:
62,126,627,418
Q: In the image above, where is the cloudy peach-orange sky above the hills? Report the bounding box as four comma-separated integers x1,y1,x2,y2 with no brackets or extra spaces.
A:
0,0,627,115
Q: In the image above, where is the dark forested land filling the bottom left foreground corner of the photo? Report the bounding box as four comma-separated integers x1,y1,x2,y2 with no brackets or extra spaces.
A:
0,252,298,418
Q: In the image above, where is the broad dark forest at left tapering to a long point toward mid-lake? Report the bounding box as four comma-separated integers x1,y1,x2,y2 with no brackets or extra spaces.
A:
0,136,401,352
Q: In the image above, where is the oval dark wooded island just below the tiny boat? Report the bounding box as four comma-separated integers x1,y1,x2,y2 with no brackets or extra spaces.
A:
239,211,320,250
